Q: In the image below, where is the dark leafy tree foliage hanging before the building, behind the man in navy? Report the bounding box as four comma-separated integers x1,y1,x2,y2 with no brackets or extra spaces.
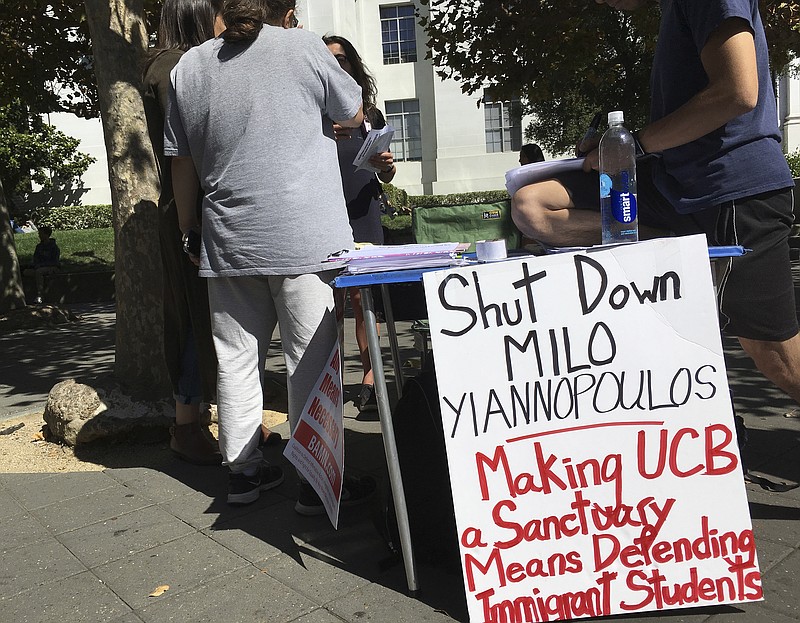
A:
421,0,800,152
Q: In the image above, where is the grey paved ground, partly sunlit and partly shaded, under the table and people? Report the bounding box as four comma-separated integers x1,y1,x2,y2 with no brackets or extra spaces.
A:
0,294,800,623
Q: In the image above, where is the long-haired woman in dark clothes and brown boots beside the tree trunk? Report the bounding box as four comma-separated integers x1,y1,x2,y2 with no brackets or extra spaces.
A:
143,0,224,465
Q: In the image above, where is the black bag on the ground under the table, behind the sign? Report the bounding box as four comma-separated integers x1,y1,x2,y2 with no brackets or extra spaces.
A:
379,358,461,572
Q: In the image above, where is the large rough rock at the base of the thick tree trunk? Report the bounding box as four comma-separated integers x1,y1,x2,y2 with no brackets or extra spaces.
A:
44,379,174,446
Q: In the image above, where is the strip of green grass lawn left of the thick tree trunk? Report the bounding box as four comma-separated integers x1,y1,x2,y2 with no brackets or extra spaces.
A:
14,227,114,272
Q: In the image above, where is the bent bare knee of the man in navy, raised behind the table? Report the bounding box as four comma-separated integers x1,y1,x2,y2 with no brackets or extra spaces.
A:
511,180,600,247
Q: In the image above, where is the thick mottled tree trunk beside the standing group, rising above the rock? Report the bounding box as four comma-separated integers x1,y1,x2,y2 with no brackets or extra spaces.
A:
85,0,169,398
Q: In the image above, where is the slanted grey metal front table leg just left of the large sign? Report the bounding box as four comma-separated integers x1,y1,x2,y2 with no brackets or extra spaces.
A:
360,286,418,596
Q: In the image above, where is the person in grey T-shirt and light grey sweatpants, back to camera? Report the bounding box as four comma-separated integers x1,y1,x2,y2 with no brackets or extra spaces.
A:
164,0,363,514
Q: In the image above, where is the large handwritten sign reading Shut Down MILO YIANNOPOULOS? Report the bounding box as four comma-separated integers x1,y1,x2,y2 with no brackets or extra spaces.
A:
424,236,762,623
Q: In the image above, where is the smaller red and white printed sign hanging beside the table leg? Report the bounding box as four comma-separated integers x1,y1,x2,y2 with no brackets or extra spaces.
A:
283,342,344,528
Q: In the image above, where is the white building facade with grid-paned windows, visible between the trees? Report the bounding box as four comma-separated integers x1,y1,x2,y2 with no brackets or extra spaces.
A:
42,0,800,205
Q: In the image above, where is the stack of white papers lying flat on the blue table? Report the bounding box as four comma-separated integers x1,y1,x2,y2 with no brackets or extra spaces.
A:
327,242,469,275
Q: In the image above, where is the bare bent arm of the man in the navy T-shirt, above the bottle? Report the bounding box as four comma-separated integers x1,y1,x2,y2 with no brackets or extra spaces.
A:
639,18,758,152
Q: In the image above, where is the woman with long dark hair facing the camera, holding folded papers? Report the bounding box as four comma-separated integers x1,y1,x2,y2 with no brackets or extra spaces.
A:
322,35,397,411
